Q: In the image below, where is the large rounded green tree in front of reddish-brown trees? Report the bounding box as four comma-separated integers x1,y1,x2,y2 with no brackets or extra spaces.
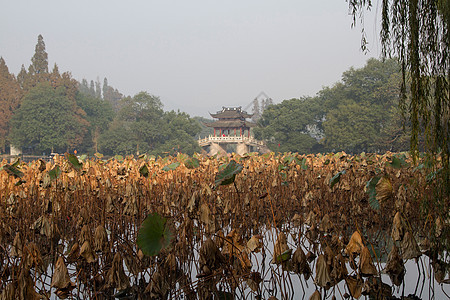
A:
10,83,83,154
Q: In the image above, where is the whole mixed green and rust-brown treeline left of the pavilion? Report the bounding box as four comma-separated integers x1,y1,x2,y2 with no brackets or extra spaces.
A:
0,35,201,155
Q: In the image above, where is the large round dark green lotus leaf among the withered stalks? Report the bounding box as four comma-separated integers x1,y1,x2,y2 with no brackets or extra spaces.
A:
137,213,173,256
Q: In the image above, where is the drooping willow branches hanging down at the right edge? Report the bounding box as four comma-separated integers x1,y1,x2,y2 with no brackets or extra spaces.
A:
349,0,450,186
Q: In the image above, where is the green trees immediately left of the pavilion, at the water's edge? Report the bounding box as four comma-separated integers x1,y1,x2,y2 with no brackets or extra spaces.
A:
99,92,200,155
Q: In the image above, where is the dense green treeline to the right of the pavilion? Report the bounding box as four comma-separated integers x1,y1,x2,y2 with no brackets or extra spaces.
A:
254,59,410,153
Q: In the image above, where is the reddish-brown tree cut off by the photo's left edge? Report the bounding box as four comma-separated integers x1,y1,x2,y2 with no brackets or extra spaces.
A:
0,57,22,152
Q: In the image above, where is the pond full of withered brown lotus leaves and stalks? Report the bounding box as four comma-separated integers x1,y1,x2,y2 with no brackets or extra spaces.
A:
0,153,450,299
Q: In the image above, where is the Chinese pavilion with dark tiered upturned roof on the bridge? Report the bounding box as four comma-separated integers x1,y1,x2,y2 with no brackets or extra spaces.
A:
205,106,256,137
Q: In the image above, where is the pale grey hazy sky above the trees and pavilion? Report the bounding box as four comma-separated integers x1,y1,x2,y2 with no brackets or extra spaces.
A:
0,0,380,116
